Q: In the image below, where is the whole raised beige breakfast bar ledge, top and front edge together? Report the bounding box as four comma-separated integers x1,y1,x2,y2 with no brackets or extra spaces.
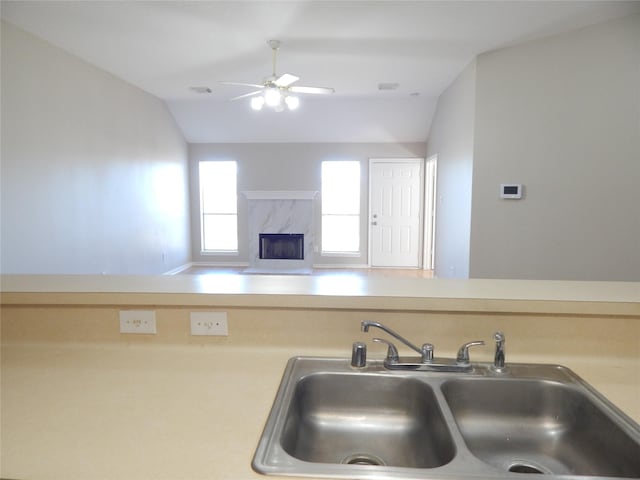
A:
0,275,640,316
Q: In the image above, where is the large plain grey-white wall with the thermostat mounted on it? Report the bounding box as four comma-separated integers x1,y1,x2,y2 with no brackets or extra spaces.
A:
470,15,640,281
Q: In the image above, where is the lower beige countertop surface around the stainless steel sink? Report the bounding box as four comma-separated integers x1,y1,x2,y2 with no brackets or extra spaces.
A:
2,345,640,480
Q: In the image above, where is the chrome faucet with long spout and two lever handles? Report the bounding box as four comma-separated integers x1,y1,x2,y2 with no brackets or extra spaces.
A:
361,320,484,372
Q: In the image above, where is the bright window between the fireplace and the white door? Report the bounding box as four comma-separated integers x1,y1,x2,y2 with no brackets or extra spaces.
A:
322,161,360,253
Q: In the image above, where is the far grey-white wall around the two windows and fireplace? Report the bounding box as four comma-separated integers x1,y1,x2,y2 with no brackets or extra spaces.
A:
189,143,426,266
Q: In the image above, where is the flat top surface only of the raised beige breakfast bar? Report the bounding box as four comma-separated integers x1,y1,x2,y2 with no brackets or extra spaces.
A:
5,275,640,302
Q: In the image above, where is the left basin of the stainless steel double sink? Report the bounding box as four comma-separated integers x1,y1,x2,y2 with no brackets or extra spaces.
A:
280,373,455,468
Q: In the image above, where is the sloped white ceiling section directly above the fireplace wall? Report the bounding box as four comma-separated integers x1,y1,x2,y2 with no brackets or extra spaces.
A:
167,96,435,143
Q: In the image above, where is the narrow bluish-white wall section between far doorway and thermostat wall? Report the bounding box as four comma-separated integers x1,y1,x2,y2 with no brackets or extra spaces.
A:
427,61,476,278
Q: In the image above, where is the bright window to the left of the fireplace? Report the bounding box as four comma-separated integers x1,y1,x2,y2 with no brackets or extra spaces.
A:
199,161,238,252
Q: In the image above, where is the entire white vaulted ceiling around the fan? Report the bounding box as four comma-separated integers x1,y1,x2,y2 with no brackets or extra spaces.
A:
1,0,640,142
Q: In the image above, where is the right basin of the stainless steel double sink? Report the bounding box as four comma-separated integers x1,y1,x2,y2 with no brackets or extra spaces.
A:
442,379,640,478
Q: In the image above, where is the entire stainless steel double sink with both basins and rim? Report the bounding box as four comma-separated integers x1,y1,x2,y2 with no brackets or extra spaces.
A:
253,357,640,480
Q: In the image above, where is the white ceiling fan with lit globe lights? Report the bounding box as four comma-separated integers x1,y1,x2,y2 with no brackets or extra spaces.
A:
219,40,334,112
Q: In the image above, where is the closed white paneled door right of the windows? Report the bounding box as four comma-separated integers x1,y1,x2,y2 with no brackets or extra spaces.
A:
369,158,423,268
